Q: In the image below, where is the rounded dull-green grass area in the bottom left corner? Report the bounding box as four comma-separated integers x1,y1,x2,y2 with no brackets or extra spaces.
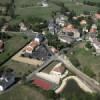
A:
0,85,48,100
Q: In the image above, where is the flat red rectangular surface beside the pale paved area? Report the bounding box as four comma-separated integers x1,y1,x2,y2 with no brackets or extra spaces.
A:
33,79,52,90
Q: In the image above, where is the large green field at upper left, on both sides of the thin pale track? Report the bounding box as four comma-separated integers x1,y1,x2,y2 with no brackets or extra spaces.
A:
16,0,60,19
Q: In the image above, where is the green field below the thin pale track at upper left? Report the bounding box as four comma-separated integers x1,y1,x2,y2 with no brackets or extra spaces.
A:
16,3,60,19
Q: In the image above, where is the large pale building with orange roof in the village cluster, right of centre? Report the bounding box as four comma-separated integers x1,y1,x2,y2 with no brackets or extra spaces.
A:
58,24,80,44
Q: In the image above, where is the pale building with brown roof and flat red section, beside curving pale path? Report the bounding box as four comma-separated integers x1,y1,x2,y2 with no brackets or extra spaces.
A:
33,63,68,90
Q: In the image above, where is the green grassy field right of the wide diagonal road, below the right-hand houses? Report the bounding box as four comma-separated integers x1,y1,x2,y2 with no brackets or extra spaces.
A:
67,43,100,78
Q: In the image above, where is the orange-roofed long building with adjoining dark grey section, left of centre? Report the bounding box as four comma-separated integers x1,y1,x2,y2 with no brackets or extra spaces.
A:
21,33,56,61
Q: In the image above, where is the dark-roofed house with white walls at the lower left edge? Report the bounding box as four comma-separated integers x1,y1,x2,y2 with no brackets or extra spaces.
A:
0,72,15,91
